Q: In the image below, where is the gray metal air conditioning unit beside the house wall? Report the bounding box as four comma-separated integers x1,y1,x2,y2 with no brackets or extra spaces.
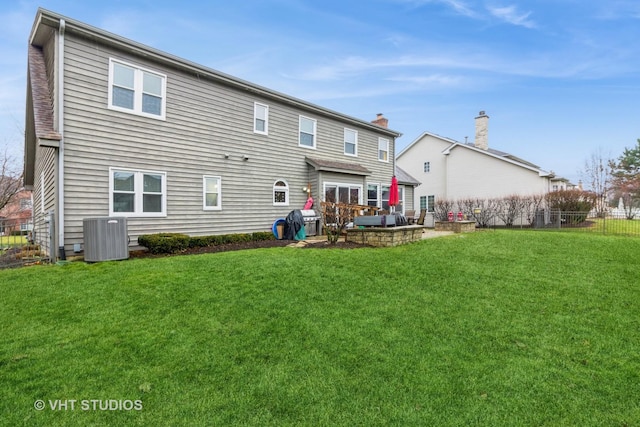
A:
82,217,129,262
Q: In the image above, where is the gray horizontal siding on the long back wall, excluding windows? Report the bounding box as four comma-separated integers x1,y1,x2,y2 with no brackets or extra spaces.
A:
64,37,393,249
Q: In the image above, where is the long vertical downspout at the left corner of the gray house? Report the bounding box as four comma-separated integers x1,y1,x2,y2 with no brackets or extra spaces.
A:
56,19,67,260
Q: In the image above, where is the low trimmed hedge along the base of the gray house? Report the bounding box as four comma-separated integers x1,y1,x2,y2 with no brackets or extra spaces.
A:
138,231,275,254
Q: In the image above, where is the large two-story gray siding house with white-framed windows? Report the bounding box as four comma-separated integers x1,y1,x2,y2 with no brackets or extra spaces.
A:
24,9,404,256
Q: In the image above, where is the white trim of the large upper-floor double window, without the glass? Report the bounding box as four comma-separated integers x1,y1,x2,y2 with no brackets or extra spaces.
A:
107,58,167,120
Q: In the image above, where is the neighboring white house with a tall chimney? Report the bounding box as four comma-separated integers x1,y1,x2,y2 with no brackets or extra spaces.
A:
396,111,555,212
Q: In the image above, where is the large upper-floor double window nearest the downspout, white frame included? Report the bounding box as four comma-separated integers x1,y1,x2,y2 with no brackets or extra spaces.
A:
108,58,167,120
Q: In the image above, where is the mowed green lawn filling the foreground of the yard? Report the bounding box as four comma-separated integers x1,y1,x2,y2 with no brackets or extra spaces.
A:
0,231,640,426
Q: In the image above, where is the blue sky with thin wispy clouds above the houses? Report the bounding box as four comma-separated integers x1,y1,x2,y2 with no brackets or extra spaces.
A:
0,0,640,186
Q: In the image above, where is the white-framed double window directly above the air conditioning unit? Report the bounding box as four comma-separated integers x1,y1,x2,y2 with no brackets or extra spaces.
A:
109,168,167,217
